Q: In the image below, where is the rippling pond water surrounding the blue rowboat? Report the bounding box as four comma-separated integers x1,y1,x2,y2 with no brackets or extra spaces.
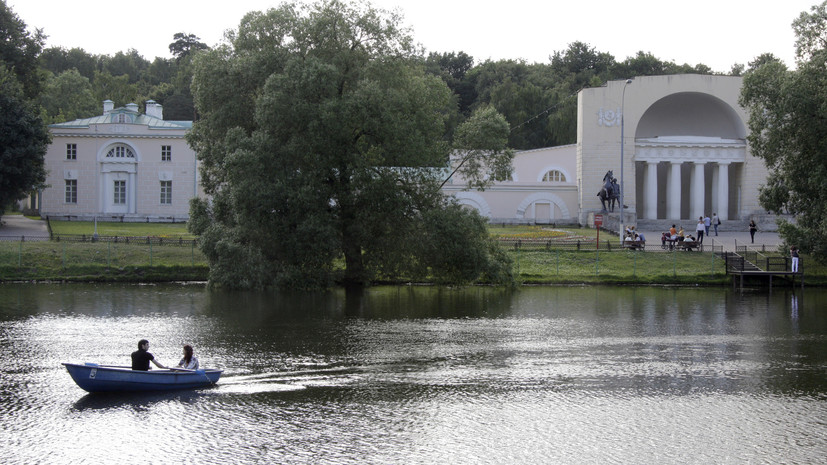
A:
0,285,827,464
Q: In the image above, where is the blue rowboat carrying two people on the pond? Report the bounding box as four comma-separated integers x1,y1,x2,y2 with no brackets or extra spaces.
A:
63,363,223,392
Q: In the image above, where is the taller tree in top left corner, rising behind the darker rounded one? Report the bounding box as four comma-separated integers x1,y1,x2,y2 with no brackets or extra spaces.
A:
0,0,46,99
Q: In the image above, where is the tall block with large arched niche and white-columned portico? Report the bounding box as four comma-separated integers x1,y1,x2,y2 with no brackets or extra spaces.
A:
577,74,767,224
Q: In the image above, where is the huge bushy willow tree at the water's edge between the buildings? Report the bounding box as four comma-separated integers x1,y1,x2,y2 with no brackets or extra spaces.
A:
188,1,512,288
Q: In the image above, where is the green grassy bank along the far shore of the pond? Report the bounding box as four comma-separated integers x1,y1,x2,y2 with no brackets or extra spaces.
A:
0,221,827,285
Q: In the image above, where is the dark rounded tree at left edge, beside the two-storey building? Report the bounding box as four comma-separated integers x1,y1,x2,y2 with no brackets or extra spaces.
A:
0,64,50,218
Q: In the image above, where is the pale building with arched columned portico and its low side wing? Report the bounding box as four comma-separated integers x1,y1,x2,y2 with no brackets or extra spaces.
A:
446,74,774,229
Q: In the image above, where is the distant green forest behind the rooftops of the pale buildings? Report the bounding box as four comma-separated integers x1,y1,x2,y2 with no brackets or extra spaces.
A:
38,37,753,150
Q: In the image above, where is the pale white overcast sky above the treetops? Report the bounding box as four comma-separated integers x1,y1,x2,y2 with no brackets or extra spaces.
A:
6,0,821,73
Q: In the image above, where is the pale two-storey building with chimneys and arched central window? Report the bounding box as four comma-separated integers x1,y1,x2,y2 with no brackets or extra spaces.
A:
40,100,203,221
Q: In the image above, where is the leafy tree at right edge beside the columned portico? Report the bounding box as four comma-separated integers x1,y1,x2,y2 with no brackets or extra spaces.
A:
740,2,827,261
